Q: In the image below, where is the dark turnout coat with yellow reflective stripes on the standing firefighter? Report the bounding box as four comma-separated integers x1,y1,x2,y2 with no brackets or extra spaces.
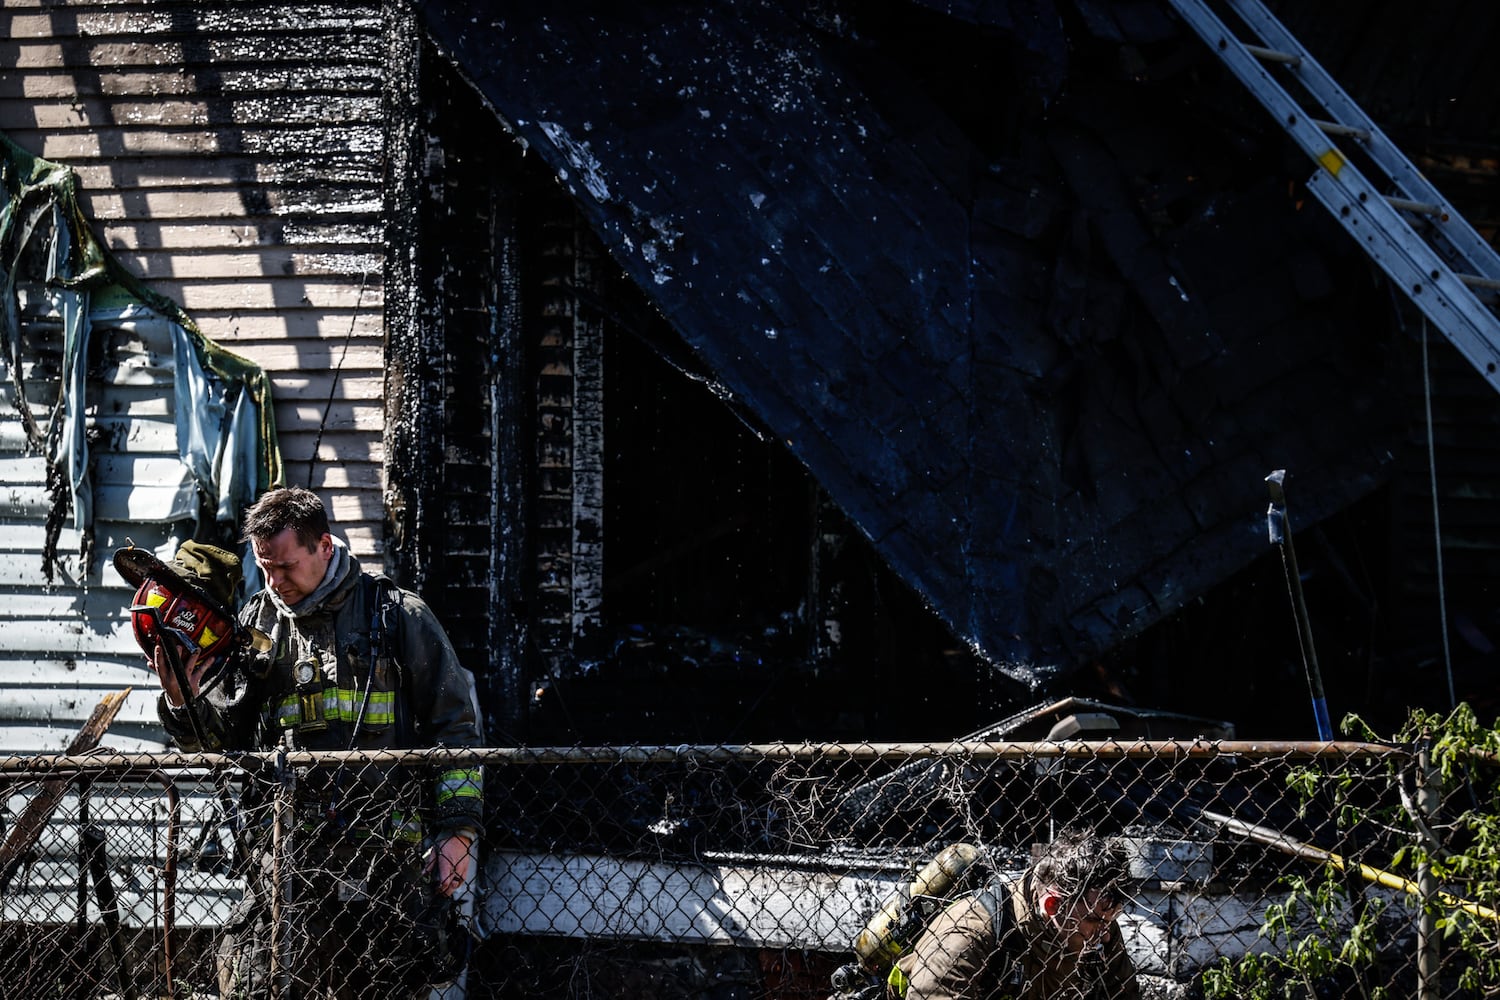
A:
158,543,483,841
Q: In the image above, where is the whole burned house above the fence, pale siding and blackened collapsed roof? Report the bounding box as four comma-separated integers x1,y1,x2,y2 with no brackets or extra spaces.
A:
0,0,1496,747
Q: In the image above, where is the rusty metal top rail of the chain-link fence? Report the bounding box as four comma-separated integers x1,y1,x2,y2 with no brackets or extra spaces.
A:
0,739,1412,778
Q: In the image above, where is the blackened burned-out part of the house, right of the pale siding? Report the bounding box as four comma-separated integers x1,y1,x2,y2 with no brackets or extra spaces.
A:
408,3,1493,741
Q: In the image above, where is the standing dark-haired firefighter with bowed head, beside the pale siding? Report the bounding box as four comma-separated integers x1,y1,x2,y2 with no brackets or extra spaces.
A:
127,487,483,997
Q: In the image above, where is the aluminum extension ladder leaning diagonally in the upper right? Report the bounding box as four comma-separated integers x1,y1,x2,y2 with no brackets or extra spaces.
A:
1169,0,1500,390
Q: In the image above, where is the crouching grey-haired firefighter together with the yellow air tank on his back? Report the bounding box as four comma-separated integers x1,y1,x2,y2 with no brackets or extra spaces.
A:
833,831,1140,1000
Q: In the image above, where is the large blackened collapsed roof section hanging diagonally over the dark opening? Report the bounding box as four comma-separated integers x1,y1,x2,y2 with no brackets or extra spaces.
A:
422,0,1389,679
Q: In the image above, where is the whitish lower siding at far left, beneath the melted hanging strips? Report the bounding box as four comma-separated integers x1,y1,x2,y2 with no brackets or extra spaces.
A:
0,305,197,753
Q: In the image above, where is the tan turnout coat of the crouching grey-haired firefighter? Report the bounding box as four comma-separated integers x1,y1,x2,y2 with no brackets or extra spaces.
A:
896,880,1140,1000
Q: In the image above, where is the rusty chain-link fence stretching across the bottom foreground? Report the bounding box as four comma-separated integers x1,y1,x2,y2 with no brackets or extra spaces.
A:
0,741,1500,1000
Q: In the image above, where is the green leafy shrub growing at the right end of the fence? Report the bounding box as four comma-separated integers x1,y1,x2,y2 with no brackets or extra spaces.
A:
1203,705,1500,1000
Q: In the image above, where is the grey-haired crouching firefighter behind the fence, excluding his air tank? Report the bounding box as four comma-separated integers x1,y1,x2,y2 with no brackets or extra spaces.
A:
887,831,1140,1000
